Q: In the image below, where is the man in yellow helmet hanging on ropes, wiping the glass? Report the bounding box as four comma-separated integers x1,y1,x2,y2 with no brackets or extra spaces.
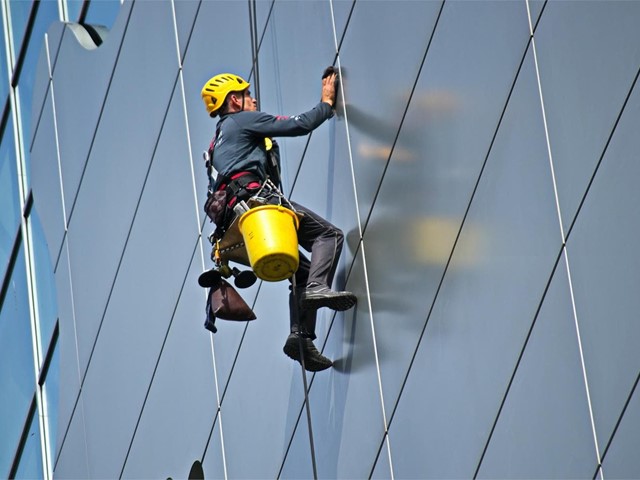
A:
202,67,356,371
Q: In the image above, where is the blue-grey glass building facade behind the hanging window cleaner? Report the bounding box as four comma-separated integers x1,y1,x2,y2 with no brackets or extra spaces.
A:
5,0,640,478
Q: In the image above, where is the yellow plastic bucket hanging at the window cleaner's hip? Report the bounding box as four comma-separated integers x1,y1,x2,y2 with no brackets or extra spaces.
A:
238,205,300,282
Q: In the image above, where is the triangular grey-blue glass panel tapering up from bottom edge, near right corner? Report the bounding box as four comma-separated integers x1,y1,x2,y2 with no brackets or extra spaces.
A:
478,256,598,479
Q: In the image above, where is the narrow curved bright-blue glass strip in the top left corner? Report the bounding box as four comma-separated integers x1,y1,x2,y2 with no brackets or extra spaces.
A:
17,1,58,190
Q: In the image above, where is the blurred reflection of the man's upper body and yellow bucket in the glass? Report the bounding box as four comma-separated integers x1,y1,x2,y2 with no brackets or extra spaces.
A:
342,78,481,275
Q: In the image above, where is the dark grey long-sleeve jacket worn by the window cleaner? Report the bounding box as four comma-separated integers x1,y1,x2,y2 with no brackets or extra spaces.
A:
209,102,333,185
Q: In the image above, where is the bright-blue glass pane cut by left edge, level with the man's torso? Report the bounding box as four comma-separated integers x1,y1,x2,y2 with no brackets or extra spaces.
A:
0,118,20,278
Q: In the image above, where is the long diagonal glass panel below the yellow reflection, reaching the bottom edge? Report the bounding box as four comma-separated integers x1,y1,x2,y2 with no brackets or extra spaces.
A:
388,50,562,478
